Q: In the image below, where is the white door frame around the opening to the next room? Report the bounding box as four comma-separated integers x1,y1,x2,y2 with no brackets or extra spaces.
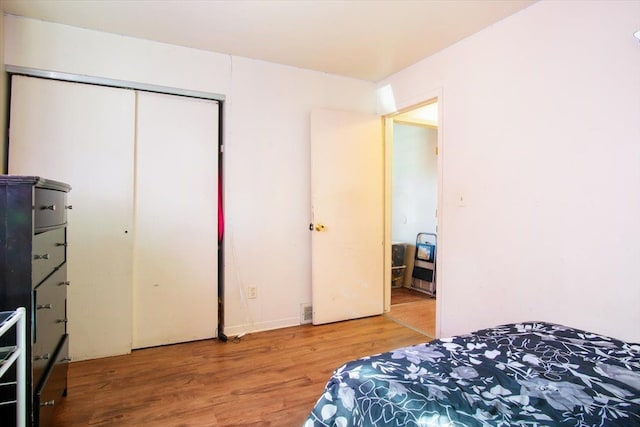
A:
383,89,446,338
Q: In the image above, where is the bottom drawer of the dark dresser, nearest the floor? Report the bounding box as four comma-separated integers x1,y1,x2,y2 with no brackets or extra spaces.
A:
33,335,69,427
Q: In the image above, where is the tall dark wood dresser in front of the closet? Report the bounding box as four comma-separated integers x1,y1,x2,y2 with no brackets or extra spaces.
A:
0,175,71,426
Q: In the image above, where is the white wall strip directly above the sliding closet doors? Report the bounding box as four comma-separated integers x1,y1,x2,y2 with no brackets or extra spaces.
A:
5,15,231,93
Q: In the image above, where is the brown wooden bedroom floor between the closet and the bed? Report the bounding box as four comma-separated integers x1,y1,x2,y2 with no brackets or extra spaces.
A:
54,316,429,427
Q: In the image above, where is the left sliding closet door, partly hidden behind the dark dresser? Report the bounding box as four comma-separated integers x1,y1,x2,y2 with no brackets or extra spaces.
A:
9,76,135,360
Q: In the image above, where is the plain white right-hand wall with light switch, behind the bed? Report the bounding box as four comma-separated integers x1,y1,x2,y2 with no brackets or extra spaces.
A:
380,0,640,341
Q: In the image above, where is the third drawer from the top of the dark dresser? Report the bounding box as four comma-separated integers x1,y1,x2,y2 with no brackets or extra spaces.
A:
32,264,67,385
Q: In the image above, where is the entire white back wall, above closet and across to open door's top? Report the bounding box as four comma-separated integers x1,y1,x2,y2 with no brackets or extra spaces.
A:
5,16,375,356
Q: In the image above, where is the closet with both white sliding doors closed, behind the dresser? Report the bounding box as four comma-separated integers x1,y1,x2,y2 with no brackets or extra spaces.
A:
8,76,219,360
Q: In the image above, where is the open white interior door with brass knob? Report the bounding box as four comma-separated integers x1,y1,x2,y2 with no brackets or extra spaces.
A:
311,110,384,324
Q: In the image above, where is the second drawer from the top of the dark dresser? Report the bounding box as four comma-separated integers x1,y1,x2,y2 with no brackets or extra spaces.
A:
31,228,67,286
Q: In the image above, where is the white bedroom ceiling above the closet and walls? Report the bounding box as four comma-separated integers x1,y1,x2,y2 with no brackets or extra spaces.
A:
2,0,535,81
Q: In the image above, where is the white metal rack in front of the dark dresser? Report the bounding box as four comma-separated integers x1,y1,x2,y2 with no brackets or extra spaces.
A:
0,307,27,427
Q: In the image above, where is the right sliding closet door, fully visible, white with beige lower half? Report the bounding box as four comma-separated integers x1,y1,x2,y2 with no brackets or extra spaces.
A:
133,92,218,348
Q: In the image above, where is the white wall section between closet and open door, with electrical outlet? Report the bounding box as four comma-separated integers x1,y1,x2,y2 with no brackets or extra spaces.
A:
225,57,375,335
